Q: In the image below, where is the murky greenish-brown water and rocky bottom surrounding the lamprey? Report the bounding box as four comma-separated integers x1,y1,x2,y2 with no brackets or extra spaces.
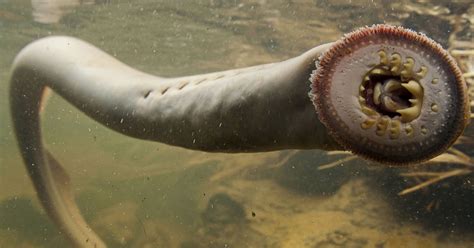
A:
0,0,474,248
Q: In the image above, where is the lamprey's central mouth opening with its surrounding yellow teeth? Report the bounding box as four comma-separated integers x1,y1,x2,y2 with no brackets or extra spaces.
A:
359,49,428,139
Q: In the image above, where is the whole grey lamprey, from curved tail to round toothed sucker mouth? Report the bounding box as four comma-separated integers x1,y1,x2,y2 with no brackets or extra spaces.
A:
10,25,468,247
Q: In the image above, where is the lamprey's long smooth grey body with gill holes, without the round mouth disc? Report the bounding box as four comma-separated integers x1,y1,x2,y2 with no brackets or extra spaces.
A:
10,37,339,247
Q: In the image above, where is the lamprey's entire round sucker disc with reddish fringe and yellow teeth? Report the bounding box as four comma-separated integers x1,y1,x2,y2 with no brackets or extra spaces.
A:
310,25,469,165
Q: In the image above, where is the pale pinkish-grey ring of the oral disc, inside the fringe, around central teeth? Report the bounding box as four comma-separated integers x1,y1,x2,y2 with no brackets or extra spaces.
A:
329,44,452,146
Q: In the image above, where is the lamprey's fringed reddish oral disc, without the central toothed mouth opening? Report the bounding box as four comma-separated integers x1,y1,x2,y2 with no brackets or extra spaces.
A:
311,25,469,165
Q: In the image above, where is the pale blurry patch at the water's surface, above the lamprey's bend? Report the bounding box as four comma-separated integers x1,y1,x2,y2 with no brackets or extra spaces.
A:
31,0,95,24
